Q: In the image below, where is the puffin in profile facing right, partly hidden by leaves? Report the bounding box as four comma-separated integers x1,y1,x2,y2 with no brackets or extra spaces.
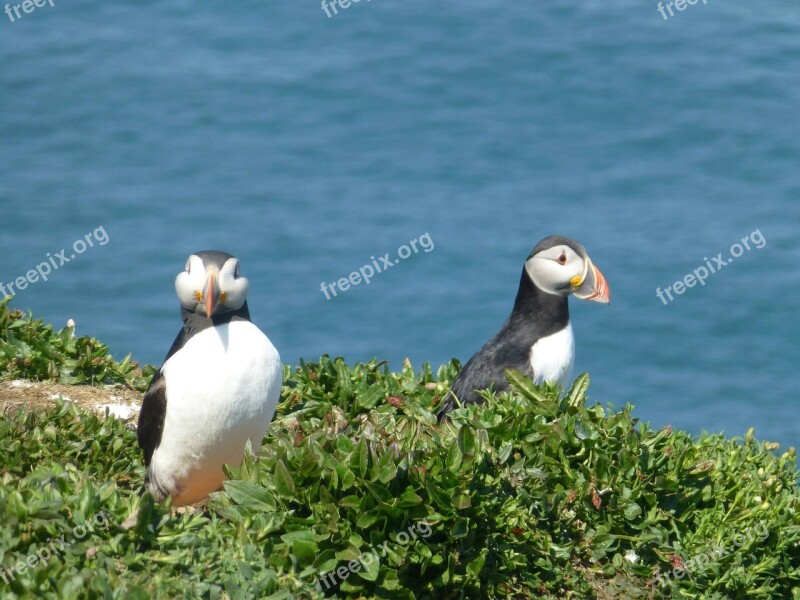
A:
437,235,611,422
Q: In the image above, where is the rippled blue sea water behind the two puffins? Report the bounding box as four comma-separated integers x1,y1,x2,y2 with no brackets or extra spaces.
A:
0,0,800,445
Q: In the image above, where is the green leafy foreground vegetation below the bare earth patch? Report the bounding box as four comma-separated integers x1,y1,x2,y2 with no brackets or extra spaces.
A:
0,302,800,599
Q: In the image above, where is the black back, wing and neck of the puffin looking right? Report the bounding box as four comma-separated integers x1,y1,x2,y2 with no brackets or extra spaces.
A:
437,270,569,421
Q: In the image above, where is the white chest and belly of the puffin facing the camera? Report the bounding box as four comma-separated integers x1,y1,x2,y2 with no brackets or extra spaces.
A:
153,321,283,505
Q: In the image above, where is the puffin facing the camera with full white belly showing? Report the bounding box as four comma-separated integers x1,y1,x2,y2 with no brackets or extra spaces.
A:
137,250,283,506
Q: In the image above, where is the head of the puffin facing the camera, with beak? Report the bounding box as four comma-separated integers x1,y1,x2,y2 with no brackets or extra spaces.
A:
175,250,250,318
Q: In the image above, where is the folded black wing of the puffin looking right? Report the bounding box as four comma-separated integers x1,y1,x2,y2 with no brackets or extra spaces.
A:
436,322,532,422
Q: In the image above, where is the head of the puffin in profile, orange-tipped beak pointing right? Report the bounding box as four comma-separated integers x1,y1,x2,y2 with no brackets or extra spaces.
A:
525,235,611,304
